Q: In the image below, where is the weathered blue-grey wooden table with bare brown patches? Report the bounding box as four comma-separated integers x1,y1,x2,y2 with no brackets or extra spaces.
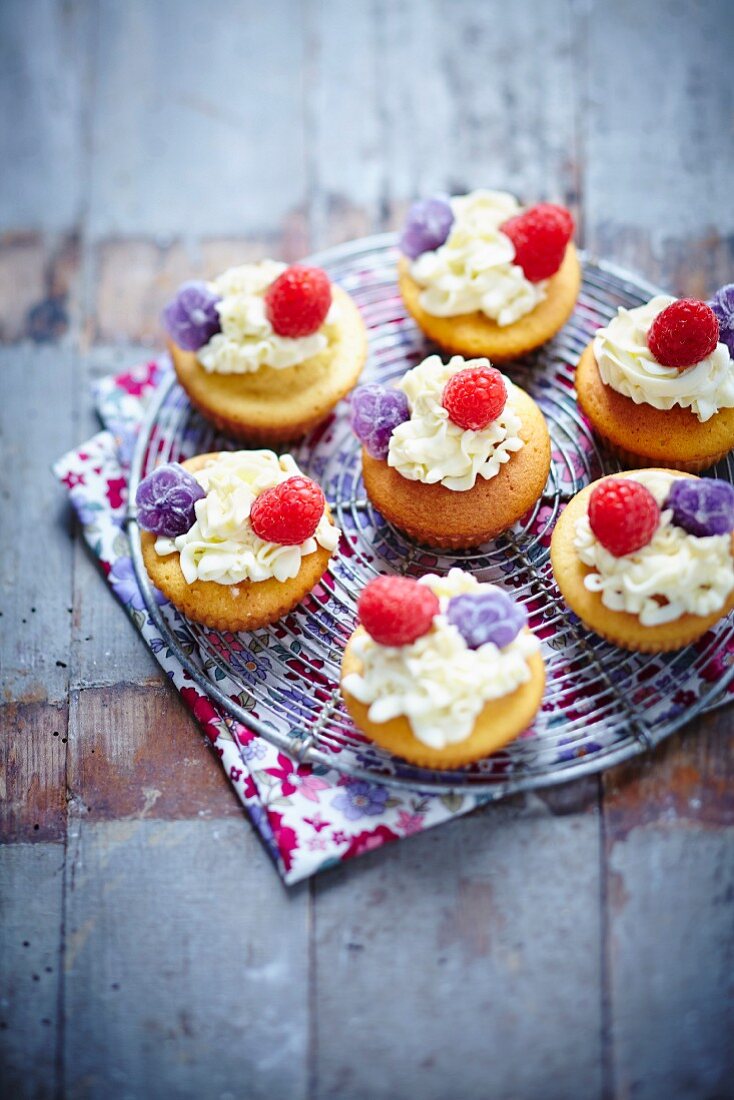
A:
0,0,734,1100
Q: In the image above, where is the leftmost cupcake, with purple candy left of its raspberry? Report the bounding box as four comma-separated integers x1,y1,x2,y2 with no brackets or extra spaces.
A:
135,451,339,630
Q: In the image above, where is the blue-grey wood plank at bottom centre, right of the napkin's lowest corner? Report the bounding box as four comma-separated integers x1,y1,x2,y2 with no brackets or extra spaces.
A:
314,803,601,1100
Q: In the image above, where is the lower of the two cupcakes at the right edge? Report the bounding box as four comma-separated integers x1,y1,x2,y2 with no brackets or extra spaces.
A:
550,469,734,653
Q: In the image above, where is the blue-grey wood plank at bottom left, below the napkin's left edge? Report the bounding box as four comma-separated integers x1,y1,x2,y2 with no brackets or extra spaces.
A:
64,818,308,1100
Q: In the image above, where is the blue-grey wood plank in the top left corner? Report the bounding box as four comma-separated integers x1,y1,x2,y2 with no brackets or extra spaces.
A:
0,0,89,231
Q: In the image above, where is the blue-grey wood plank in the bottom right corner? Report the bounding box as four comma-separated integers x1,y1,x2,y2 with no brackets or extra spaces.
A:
609,824,734,1100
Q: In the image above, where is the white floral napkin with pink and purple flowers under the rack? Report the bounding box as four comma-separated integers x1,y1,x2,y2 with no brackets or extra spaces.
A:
54,358,482,884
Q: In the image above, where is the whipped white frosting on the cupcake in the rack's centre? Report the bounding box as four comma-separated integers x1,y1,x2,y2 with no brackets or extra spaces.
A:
387,355,525,493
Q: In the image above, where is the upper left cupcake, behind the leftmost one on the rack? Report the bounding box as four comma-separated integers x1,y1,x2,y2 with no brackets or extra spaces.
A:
163,260,366,443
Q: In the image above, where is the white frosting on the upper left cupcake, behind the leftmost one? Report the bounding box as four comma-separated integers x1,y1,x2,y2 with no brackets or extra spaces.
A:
197,260,338,374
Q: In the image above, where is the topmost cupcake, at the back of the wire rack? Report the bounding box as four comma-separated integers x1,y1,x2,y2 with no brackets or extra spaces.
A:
398,190,581,362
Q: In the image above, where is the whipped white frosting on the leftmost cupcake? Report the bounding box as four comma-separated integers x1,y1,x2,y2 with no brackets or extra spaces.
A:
155,451,339,584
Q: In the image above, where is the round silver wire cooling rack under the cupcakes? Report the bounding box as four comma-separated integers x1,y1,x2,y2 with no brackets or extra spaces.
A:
129,234,734,799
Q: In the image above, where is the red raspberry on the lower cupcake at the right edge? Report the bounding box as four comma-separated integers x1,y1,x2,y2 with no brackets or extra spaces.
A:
589,477,660,558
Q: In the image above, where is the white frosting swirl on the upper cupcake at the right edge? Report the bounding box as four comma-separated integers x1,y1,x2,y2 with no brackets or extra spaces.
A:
593,294,734,422
